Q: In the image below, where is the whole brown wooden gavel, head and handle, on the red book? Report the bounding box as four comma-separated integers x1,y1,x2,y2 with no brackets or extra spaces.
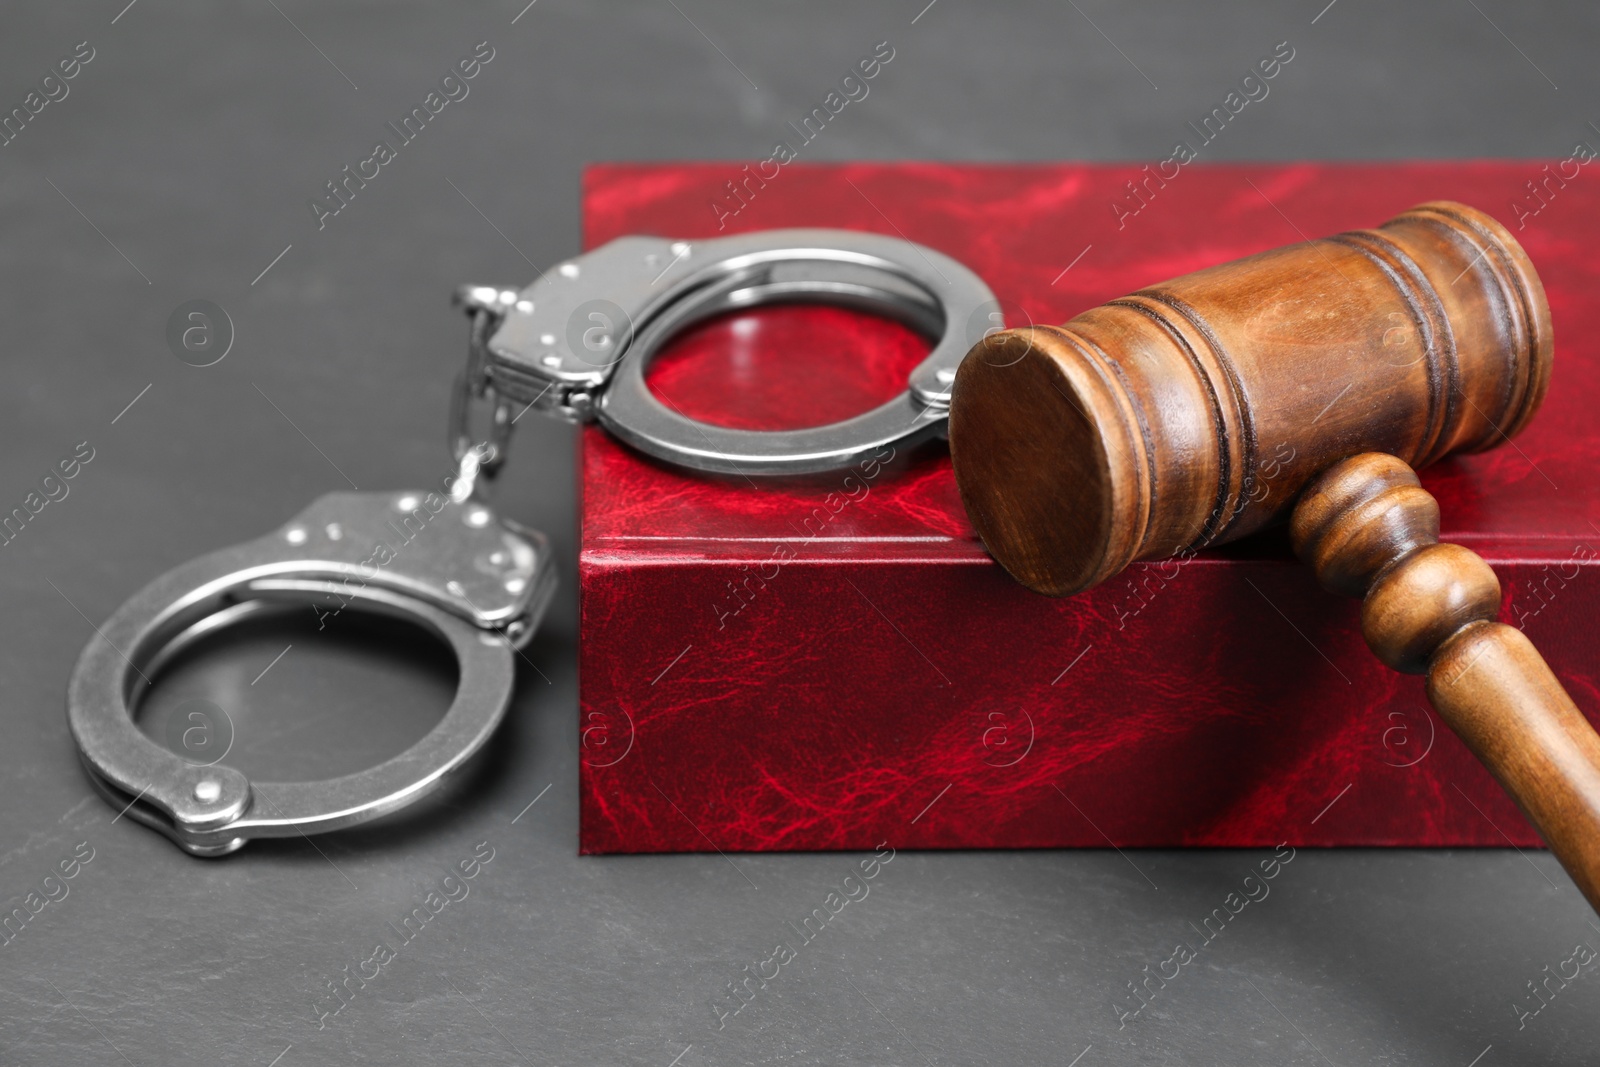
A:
950,202,1600,910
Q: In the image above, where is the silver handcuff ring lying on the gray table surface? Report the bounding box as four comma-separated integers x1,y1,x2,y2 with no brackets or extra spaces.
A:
67,479,555,856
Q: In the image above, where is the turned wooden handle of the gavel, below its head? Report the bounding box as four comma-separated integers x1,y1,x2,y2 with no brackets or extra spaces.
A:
1290,453,1600,912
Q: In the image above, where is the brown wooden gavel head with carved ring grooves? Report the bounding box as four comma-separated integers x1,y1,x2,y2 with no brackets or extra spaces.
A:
950,202,1552,595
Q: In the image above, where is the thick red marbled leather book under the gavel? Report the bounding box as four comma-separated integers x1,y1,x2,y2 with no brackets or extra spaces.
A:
579,162,1600,853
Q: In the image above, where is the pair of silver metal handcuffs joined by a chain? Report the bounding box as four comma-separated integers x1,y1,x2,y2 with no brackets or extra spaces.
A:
67,230,1003,856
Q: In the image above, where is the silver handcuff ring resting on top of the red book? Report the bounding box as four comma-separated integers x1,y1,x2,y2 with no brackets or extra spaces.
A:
458,230,1003,475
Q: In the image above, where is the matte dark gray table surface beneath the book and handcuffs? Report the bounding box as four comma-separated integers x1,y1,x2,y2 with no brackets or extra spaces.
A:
0,0,1600,1067
